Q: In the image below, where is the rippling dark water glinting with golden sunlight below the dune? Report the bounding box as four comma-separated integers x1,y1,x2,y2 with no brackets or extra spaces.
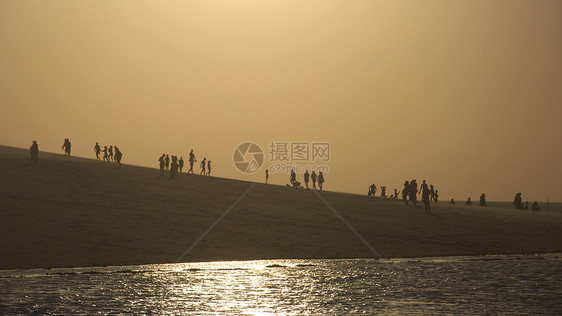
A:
0,254,562,315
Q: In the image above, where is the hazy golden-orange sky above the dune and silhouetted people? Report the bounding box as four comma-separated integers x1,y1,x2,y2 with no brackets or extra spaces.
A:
0,0,562,202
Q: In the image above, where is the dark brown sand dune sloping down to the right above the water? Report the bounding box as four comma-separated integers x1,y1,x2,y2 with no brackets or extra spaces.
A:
0,146,562,269
